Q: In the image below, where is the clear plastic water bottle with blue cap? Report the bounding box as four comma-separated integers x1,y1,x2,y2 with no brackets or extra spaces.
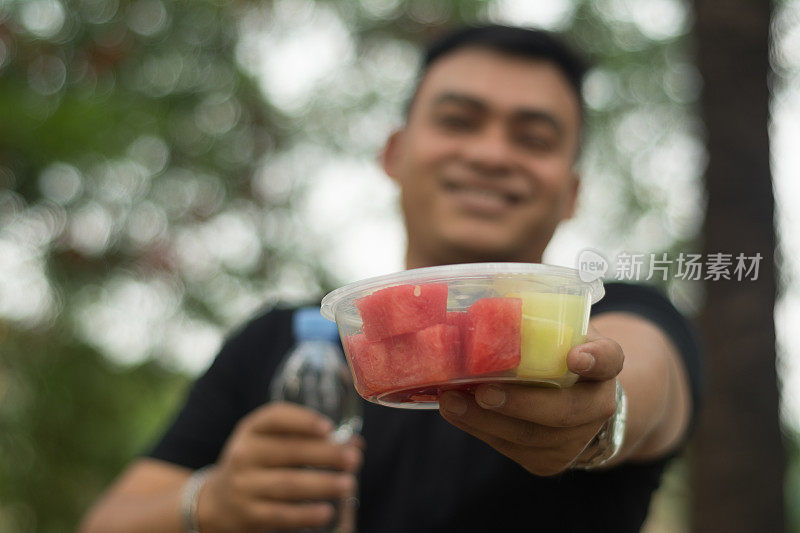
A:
270,307,362,533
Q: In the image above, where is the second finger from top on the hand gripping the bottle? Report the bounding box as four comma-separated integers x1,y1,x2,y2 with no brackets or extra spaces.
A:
249,437,363,472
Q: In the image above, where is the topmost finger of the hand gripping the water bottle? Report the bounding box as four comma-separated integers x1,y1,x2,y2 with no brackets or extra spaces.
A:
242,402,333,437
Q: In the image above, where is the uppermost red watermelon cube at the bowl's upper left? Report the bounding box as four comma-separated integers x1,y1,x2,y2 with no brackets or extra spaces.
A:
355,283,447,341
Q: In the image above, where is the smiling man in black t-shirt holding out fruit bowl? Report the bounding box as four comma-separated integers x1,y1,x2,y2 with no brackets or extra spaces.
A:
78,22,698,533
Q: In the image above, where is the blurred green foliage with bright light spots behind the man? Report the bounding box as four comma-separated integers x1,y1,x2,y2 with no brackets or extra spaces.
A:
0,0,800,533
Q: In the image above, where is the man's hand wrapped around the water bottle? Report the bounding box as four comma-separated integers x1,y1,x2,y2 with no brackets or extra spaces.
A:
197,403,362,533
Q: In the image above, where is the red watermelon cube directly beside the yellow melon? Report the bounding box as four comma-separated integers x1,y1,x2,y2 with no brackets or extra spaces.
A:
464,298,522,375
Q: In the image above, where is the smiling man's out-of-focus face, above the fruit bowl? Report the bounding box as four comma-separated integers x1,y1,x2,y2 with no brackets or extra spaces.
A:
383,48,580,267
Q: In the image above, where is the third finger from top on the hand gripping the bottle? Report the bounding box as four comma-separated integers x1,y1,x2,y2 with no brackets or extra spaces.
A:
243,468,356,501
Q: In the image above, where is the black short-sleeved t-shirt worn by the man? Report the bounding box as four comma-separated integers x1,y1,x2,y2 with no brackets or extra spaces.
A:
149,283,700,533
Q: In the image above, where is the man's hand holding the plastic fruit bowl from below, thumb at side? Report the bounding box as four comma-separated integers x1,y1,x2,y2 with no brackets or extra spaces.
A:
439,327,624,476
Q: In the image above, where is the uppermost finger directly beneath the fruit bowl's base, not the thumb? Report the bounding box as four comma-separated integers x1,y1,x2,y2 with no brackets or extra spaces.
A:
475,381,617,428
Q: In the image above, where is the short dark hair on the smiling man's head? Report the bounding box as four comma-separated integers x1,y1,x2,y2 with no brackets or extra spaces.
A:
406,24,589,117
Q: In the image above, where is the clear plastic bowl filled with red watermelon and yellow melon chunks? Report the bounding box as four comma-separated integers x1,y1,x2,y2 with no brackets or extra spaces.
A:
321,263,605,409
